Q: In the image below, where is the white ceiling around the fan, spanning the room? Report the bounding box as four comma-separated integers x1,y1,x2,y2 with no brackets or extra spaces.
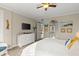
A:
0,3,79,20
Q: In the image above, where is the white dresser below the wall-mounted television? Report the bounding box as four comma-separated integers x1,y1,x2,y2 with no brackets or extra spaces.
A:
17,33,35,47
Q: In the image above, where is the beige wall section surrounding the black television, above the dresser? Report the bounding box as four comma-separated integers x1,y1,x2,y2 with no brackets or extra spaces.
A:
12,13,36,45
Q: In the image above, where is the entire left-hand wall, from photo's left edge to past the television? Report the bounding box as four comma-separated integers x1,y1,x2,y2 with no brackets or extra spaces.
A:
0,8,36,47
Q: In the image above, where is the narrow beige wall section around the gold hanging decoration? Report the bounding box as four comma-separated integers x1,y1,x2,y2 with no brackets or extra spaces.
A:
3,9,12,46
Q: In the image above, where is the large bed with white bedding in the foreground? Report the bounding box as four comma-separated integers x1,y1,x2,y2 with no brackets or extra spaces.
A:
21,38,79,56
